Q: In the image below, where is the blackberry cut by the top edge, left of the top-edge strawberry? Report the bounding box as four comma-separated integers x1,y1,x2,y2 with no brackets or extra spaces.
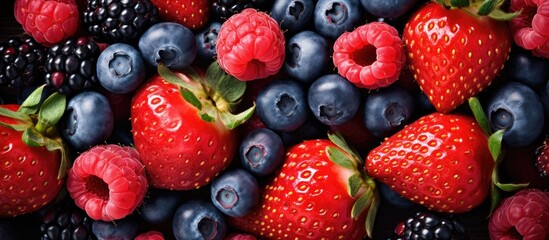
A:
84,0,158,43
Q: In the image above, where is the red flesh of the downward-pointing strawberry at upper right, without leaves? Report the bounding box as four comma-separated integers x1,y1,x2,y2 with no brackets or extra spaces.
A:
403,1,512,112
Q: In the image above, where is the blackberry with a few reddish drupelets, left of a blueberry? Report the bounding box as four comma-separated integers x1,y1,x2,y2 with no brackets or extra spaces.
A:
45,37,100,94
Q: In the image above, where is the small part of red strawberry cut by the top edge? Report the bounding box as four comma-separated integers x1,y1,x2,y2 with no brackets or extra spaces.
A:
151,0,211,30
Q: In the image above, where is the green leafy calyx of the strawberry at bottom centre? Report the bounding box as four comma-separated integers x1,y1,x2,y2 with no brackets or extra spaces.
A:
326,132,380,237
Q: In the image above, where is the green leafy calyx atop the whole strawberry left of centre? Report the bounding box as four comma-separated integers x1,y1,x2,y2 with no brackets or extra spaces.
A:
158,61,255,130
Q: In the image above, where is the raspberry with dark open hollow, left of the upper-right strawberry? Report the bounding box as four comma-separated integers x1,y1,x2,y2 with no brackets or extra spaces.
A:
333,22,406,89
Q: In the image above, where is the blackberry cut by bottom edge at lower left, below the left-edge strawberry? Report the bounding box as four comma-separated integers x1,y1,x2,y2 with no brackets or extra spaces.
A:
40,198,97,240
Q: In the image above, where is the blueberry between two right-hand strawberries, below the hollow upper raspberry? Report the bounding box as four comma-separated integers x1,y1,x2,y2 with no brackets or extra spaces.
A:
364,85,415,138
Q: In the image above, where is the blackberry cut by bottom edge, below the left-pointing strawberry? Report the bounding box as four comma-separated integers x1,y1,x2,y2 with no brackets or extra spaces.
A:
388,212,469,240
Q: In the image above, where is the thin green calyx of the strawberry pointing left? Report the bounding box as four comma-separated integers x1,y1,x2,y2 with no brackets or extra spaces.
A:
469,97,528,214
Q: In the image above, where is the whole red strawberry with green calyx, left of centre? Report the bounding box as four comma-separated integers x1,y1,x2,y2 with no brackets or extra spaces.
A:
131,62,255,190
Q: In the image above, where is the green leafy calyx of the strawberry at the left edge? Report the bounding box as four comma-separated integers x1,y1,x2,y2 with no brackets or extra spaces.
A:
0,85,69,179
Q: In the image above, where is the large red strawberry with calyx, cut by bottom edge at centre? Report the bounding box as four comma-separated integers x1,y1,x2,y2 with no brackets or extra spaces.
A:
229,135,378,239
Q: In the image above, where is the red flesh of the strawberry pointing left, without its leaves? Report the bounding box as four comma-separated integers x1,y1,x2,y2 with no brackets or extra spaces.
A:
365,113,494,213
